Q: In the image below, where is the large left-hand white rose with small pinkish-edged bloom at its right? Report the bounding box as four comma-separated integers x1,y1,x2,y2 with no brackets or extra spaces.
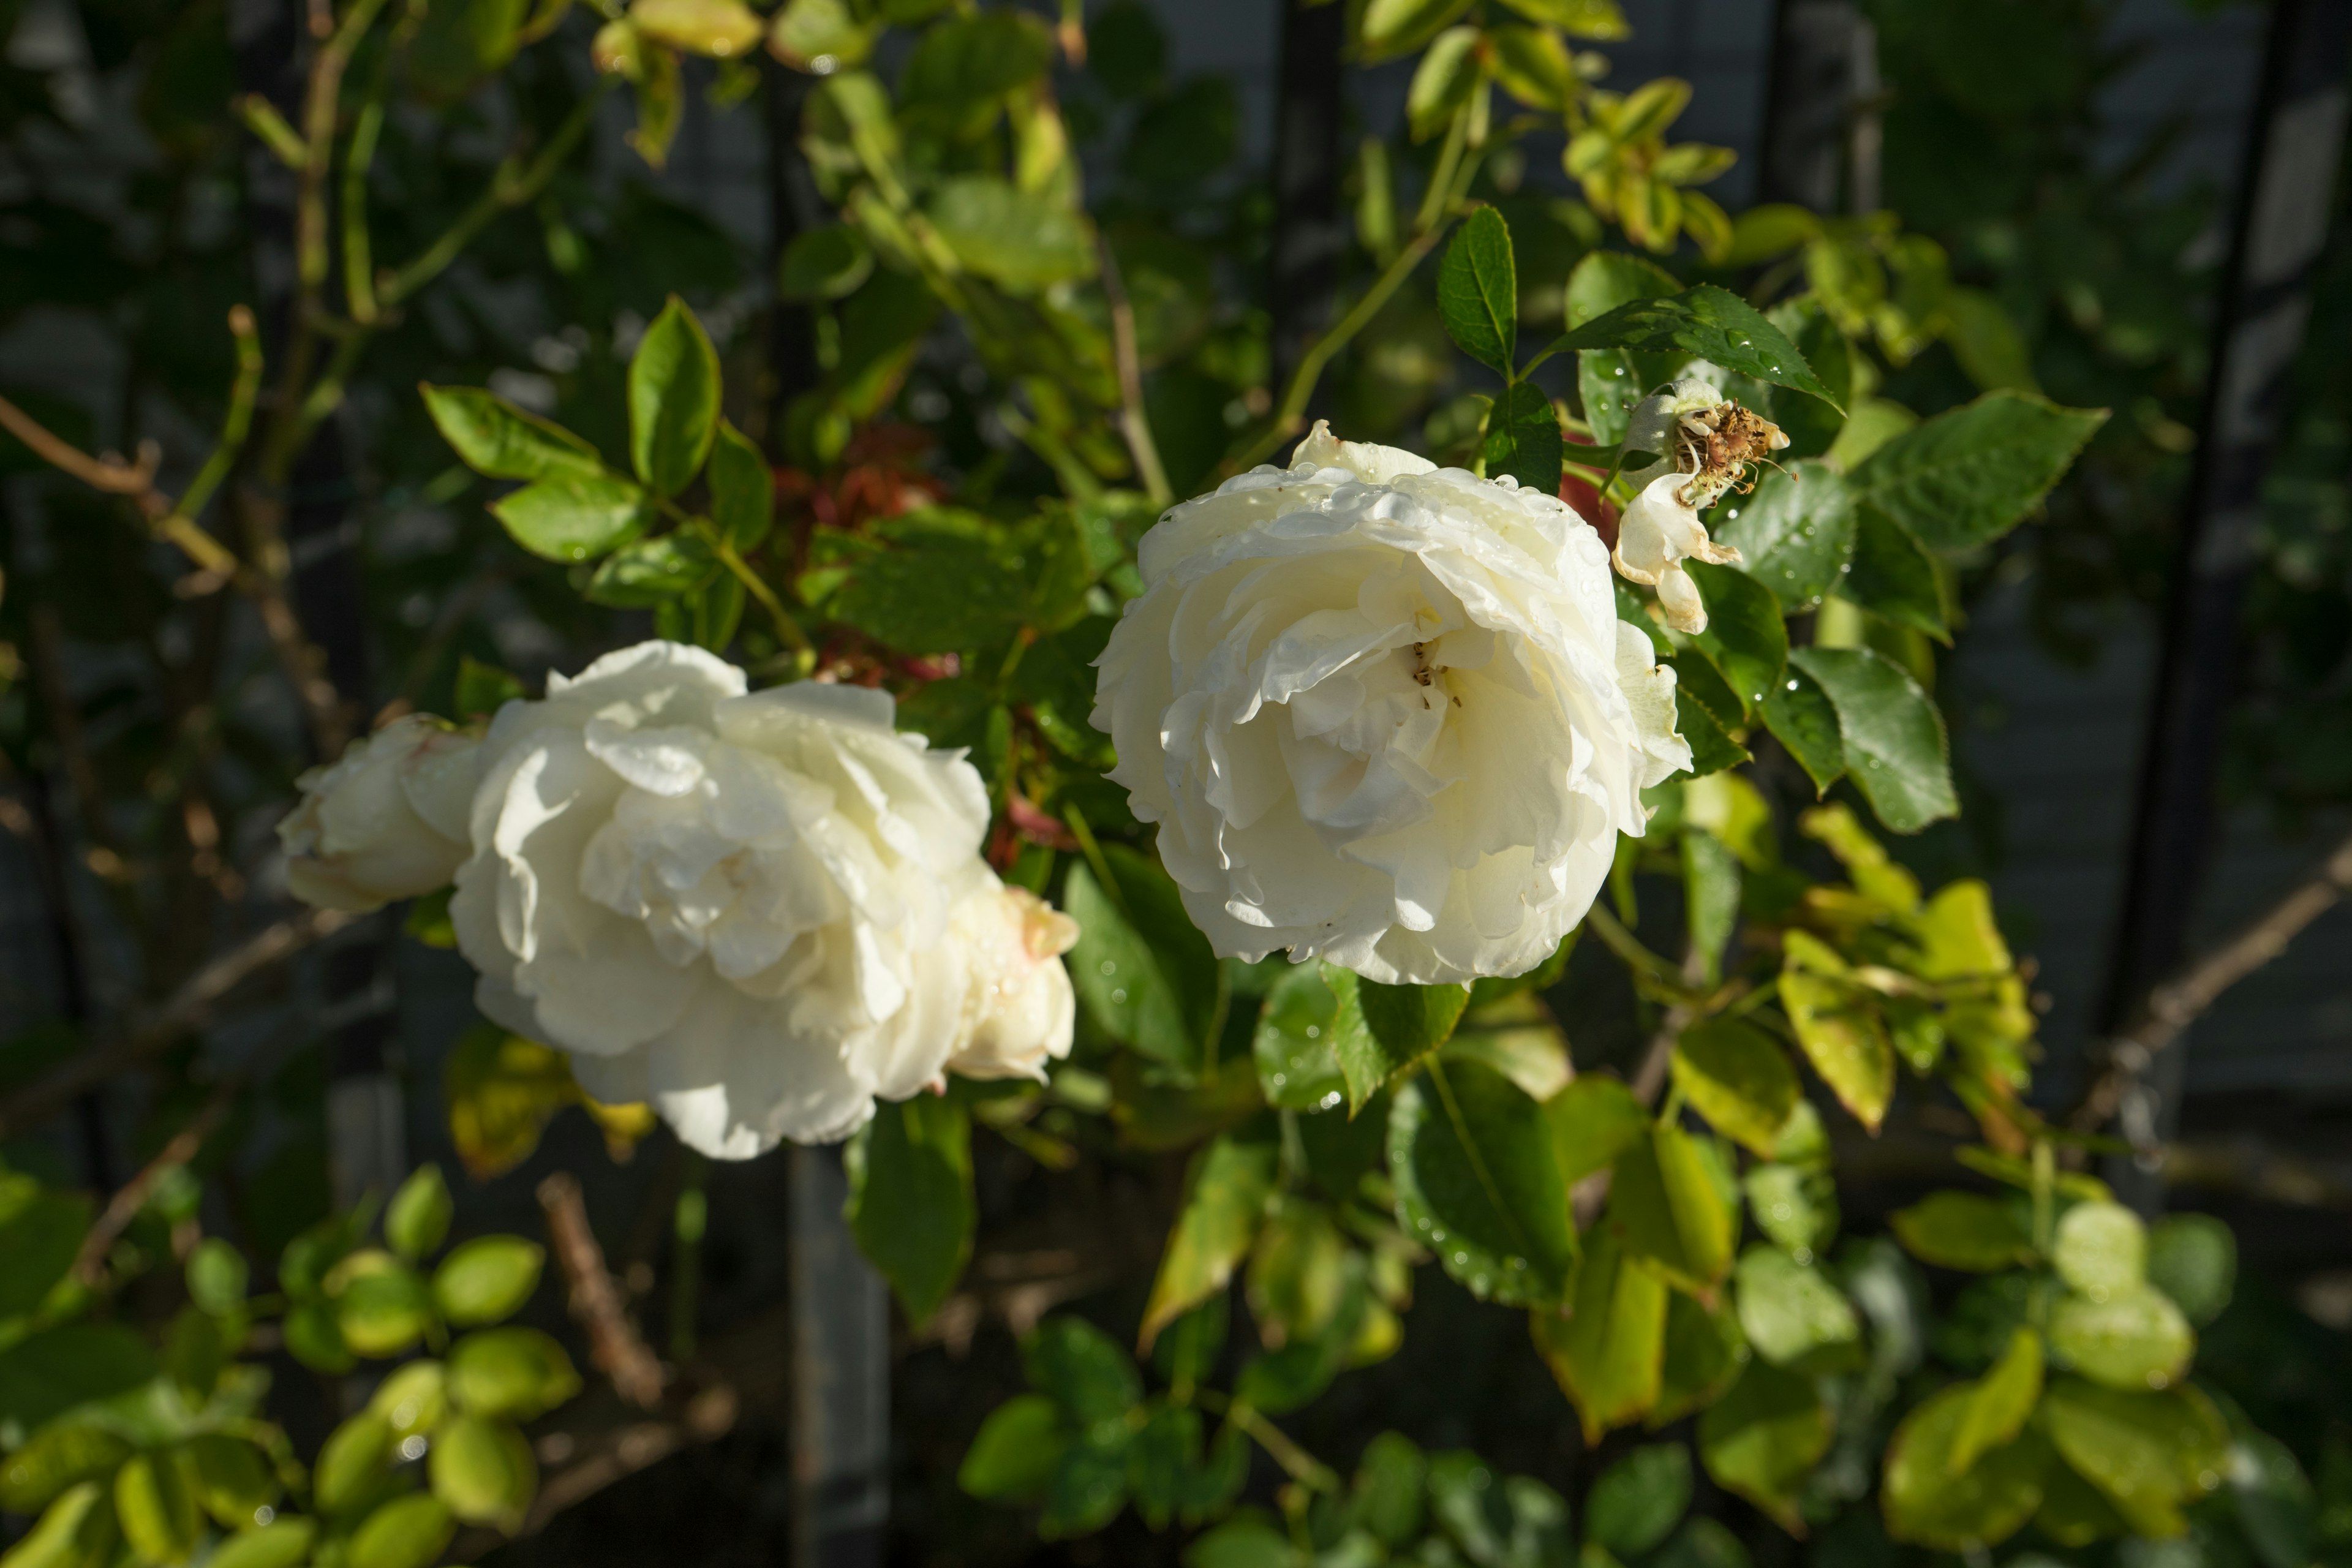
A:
449,642,1070,1159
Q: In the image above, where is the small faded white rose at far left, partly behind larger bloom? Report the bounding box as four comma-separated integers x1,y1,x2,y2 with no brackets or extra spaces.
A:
277,712,480,914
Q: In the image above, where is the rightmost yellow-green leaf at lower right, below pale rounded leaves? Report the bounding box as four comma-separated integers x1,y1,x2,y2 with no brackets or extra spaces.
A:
2041,1378,2230,1537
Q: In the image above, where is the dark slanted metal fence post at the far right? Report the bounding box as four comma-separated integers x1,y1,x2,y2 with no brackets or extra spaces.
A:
2100,0,2352,1211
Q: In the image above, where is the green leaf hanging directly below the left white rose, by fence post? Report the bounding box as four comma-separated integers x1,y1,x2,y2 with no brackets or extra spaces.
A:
842,1096,976,1329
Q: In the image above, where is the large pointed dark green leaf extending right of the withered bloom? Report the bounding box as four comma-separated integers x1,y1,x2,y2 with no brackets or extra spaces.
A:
1851,393,2108,550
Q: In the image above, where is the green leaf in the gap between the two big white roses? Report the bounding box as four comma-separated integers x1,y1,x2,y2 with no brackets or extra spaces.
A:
1063,846,1216,1069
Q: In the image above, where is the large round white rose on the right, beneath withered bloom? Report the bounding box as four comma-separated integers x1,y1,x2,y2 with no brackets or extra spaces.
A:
1094,426,1691,985
